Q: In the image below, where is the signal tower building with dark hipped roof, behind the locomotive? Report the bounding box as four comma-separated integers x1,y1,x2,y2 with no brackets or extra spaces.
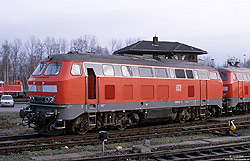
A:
113,36,207,62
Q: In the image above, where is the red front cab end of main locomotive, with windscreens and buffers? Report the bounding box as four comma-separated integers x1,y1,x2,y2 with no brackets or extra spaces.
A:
20,57,85,134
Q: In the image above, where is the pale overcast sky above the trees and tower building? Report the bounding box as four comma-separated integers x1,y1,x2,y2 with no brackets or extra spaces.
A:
0,0,250,65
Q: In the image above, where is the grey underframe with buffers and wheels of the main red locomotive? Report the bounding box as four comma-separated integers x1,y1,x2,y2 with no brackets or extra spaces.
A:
20,99,222,134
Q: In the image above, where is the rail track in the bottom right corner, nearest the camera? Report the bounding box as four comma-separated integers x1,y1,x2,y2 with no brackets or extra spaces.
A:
77,142,250,161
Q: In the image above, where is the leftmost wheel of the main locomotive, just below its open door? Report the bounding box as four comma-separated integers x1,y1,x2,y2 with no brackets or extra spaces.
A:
72,116,89,135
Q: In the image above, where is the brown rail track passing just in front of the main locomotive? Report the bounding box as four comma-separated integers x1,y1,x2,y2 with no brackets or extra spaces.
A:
0,121,250,153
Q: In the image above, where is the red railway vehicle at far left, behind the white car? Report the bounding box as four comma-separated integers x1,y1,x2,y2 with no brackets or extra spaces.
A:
0,80,23,97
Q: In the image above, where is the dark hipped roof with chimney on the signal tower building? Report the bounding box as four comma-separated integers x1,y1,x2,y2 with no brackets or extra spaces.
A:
113,36,207,56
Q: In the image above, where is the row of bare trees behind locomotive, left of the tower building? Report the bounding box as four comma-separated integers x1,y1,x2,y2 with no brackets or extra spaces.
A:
0,35,148,90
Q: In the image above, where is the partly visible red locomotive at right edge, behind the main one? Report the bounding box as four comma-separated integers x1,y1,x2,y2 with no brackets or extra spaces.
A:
218,66,250,114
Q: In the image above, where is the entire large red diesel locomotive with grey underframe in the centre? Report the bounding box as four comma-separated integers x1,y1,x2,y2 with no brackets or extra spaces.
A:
20,53,224,134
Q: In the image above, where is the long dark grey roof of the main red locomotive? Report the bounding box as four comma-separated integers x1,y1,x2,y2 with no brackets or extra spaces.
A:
42,54,215,70
